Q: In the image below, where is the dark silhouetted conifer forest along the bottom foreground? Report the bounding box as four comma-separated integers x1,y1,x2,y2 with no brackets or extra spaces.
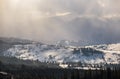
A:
0,62,120,79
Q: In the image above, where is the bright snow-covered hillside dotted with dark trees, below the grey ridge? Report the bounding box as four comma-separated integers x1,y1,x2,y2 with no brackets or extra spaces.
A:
2,41,120,64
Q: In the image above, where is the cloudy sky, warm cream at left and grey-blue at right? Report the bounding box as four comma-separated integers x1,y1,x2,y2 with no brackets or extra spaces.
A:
0,0,120,44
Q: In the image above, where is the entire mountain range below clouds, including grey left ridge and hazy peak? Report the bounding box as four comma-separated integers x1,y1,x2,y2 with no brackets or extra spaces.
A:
0,38,120,67
